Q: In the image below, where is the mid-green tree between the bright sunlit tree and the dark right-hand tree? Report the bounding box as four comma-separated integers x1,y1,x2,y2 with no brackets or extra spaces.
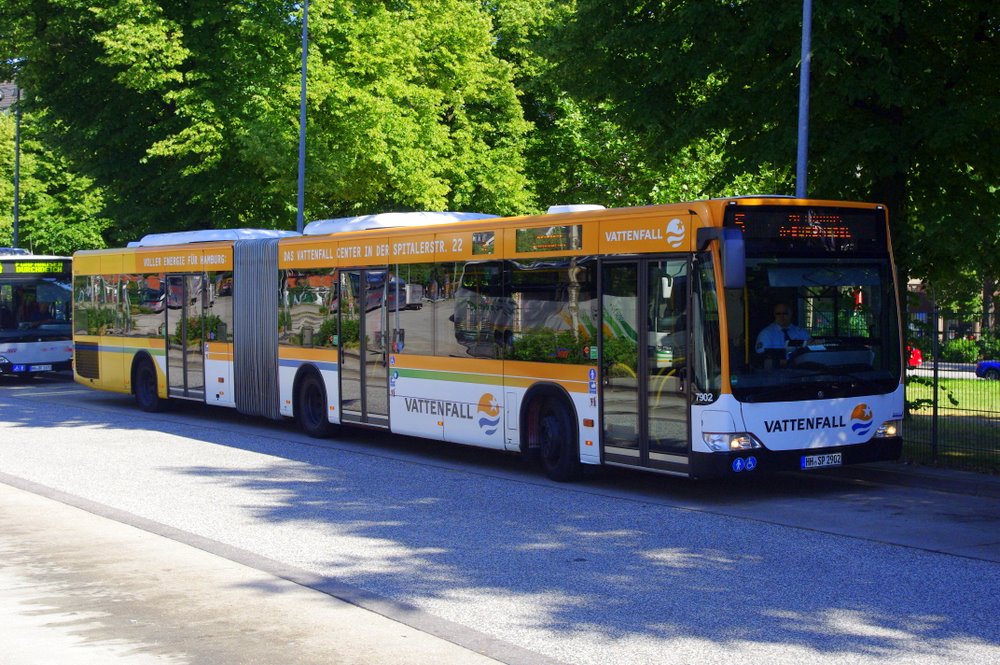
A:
492,0,786,206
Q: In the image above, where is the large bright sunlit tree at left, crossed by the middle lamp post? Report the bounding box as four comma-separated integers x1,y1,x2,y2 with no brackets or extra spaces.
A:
0,0,531,243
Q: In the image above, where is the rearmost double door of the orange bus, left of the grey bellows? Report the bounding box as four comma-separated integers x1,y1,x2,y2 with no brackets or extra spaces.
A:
163,274,205,400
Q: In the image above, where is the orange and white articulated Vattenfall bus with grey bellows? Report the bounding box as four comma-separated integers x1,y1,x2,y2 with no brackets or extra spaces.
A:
73,196,903,480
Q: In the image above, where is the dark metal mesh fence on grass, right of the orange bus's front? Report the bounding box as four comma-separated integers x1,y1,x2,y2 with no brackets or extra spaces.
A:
903,310,1000,473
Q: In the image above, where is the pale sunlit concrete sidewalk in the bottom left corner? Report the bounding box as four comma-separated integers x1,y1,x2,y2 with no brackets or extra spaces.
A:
0,483,498,665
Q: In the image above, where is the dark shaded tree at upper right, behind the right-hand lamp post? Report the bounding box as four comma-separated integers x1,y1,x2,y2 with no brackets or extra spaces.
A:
560,0,1000,290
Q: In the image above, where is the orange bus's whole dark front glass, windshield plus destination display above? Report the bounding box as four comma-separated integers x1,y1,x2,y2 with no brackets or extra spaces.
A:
726,205,902,402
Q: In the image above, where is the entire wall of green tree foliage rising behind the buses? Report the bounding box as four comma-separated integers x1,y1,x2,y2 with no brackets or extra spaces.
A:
0,0,1000,330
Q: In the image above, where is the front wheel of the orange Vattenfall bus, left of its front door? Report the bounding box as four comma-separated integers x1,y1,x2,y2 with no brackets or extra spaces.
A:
528,395,581,483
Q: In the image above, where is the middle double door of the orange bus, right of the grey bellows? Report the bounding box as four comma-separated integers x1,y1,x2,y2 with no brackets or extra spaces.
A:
339,269,389,427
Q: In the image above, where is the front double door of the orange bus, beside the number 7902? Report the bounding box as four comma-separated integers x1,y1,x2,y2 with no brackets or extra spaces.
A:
601,257,690,473
